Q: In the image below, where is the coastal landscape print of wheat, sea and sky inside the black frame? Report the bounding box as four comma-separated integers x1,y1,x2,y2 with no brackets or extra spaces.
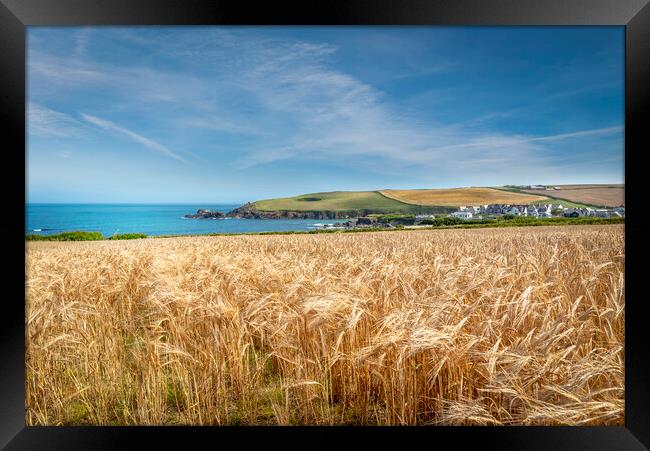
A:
25,26,625,426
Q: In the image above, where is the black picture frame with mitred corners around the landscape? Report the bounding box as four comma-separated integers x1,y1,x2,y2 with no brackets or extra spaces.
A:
0,0,650,451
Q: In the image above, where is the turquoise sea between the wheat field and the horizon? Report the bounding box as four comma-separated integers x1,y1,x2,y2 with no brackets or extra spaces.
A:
25,204,345,237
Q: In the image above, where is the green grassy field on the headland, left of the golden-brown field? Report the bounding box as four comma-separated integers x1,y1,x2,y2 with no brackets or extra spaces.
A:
255,191,448,213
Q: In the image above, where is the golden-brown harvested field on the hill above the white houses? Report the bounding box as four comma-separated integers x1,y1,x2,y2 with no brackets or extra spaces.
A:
380,188,548,206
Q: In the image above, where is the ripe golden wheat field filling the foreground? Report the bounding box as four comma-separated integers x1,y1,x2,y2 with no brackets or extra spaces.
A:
26,225,625,425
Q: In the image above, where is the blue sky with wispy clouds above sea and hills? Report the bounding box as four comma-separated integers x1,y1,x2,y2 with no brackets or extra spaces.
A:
27,27,624,203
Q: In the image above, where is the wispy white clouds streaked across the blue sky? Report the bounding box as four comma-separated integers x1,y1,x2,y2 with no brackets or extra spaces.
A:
30,29,622,185
